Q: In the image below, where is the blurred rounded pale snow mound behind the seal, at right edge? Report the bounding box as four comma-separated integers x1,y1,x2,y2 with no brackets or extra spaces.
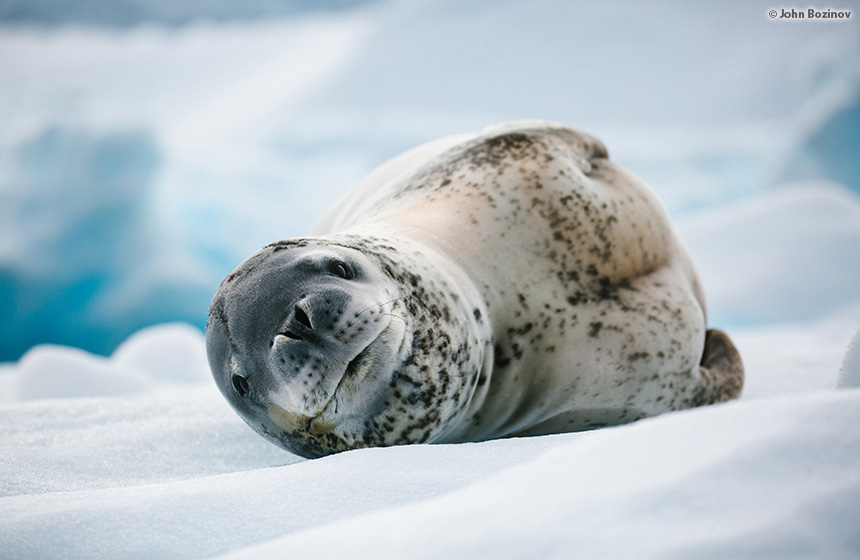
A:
676,183,860,326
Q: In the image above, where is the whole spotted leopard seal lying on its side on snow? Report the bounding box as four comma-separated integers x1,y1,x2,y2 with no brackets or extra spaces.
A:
206,121,743,457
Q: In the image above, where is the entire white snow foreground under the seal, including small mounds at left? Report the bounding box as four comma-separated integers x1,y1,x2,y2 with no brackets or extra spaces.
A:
0,308,860,559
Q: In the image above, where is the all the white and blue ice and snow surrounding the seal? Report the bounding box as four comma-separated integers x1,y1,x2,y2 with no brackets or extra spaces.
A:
0,0,860,558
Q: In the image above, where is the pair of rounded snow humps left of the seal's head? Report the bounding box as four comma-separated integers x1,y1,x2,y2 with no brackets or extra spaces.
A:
5,323,210,400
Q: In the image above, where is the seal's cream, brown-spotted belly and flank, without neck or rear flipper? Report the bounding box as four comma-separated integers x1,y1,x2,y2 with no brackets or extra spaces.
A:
362,127,704,440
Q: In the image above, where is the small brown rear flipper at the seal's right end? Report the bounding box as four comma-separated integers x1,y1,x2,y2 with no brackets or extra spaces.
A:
693,329,744,406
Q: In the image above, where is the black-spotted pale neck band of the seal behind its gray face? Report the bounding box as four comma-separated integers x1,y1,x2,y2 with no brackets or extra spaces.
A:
319,227,493,443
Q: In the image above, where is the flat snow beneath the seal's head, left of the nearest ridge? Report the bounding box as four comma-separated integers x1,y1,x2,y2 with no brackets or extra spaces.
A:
0,391,560,559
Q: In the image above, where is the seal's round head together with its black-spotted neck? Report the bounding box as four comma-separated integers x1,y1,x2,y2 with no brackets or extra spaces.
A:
206,235,489,457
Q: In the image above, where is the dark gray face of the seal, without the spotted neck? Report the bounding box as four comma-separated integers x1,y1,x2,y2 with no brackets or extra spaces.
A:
206,238,411,457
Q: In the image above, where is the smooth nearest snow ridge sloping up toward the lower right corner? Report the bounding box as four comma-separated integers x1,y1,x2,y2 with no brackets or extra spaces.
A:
221,390,860,560
